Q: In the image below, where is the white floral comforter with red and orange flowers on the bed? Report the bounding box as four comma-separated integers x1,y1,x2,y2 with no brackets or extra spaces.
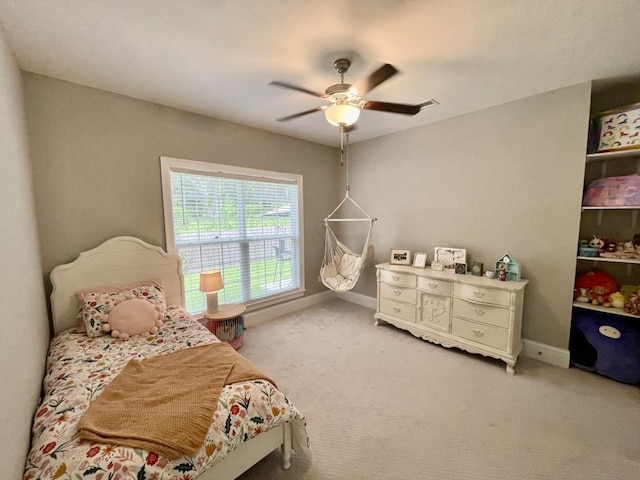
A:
24,307,307,480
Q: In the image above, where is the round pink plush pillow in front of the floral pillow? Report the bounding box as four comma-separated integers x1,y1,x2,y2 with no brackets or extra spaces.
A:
102,298,162,340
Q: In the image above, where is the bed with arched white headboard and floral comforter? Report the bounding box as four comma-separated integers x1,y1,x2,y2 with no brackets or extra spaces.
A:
24,237,310,480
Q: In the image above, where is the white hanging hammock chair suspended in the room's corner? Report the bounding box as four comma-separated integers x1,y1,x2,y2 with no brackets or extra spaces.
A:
320,128,376,293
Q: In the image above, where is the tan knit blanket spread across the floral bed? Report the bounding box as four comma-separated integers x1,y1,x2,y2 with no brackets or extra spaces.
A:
78,342,275,460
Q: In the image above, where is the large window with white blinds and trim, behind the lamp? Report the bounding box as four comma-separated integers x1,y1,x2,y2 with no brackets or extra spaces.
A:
160,157,304,313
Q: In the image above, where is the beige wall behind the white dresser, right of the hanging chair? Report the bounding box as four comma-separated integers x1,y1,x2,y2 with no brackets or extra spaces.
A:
350,84,591,349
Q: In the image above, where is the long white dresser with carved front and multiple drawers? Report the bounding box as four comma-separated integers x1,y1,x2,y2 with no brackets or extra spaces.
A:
375,263,528,375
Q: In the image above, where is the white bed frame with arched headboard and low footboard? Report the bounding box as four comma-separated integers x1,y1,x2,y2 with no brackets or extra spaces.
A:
51,236,291,480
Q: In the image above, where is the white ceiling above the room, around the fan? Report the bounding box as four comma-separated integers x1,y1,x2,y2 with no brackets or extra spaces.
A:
0,0,640,145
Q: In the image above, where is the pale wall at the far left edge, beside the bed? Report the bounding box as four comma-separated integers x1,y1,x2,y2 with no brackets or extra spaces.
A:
0,24,49,480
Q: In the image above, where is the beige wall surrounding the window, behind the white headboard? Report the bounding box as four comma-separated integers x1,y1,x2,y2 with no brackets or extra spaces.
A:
24,73,340,294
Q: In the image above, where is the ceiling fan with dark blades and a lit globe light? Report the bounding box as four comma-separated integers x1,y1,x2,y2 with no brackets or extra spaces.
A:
269,58,438,128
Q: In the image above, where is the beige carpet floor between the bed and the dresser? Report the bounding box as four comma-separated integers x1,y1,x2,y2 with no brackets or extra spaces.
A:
240,300,640,480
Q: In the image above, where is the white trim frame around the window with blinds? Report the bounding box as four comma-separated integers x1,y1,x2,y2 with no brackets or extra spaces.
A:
160,156,306,311
